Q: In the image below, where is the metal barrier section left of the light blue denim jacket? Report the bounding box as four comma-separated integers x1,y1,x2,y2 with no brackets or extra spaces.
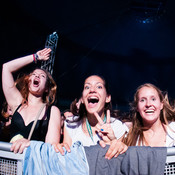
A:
0,142,25,175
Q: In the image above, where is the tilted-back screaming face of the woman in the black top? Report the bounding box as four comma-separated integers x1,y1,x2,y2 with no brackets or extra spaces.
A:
29,69,47,95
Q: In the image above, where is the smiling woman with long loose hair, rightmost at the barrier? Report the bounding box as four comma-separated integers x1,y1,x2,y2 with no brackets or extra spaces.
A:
125,83,175,147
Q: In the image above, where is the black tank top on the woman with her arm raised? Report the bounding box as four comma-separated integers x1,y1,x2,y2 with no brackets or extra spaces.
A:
10,105,51,142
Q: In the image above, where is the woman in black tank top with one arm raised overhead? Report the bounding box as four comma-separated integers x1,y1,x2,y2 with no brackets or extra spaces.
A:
2,48,61,153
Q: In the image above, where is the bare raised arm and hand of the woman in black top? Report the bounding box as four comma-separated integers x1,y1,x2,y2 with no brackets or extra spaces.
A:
2,48,51,112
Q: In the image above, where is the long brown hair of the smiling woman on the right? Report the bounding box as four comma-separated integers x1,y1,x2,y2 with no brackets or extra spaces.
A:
124,83,175,146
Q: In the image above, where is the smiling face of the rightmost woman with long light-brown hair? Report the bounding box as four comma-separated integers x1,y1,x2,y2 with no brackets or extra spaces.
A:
137,86,163,125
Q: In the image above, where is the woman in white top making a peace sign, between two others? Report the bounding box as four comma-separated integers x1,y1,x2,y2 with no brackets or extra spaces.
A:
57,75,127,158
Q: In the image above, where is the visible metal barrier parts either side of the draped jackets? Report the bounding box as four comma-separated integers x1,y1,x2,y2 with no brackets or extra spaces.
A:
0,141,175,175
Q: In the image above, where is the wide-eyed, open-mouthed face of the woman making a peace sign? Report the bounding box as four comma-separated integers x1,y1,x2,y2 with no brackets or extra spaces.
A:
82,75,111,114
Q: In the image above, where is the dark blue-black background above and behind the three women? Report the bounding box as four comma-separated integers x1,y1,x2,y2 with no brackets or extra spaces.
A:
0,0,175,111
